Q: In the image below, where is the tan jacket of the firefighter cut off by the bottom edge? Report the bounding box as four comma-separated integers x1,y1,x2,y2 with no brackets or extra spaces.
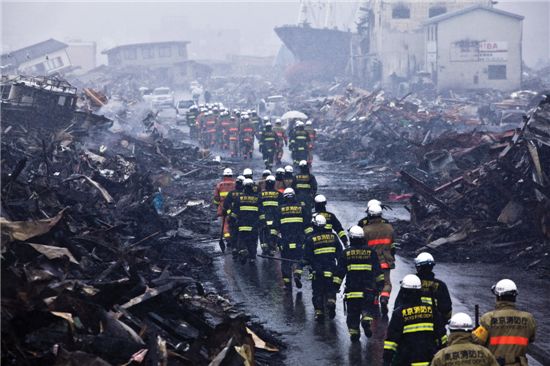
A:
432,332,498,366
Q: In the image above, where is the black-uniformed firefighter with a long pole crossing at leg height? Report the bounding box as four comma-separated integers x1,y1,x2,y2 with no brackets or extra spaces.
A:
274,188,307,289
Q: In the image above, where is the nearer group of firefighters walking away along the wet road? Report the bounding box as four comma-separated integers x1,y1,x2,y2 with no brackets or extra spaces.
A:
214,166,536,366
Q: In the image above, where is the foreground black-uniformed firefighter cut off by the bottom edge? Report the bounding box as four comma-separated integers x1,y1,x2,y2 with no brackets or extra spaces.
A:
383,274,445,366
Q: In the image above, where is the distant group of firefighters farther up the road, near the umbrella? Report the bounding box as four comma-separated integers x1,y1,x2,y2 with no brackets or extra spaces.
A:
186,103,316,169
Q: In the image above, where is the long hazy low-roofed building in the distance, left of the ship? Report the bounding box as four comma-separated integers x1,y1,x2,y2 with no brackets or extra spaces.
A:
102,41,189,68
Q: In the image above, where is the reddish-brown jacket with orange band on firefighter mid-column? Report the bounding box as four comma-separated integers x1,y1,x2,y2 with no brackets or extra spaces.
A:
363,217,395,270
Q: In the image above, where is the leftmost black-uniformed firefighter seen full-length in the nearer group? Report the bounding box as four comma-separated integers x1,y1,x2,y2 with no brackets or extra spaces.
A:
231,178,262,264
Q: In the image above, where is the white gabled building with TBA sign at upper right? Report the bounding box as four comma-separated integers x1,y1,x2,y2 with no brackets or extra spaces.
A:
424,5,523,90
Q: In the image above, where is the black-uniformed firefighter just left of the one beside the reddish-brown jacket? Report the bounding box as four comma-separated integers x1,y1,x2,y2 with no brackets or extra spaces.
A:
304,214,342,320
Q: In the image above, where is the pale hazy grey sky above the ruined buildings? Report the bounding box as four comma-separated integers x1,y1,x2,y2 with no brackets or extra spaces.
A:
0,0,550,65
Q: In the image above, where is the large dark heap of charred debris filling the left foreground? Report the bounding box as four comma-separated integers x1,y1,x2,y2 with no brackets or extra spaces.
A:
0,76,281,365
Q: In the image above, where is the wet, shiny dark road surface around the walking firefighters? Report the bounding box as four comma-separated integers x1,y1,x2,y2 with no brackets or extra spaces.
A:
191,139,550,366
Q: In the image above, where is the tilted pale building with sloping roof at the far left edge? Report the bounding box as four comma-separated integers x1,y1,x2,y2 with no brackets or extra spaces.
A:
2,39,72,76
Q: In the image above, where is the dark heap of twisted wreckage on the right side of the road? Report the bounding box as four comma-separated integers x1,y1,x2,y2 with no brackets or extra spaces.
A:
401,93,550,271
